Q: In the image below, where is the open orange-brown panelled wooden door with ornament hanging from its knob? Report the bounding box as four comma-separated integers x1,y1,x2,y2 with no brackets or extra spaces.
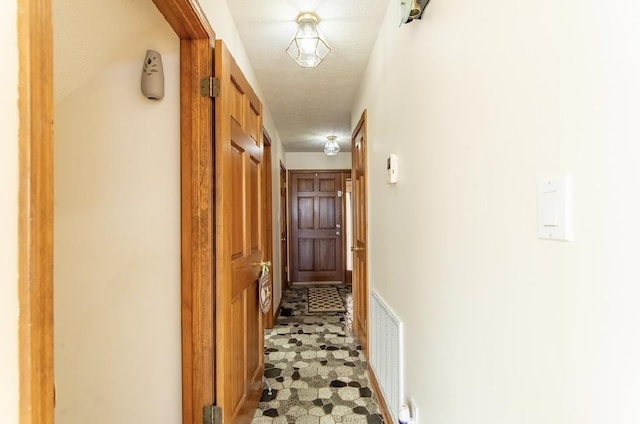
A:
212,40,266,424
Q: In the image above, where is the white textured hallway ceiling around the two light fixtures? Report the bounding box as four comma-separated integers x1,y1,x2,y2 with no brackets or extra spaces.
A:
228,0,388,152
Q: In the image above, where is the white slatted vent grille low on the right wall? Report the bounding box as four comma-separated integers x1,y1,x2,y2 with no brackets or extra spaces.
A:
369,290,403,422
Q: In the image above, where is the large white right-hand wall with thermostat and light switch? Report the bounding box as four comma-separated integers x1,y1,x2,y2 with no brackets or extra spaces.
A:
352,0,640,424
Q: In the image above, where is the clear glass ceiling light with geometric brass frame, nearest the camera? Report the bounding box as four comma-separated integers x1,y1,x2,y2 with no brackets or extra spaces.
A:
287,13,331,68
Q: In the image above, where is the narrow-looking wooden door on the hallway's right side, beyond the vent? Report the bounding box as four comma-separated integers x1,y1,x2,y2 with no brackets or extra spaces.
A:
351,111,369,350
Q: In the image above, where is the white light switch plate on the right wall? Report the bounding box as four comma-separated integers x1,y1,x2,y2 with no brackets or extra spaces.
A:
538,176,573,241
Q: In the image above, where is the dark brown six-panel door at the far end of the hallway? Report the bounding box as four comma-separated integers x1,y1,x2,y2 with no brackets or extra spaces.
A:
289,171,344,282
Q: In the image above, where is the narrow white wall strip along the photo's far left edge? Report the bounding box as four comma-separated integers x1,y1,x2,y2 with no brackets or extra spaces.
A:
0,1,18,424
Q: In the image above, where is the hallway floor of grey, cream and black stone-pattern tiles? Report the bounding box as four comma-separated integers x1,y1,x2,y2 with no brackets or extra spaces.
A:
253,285,382,424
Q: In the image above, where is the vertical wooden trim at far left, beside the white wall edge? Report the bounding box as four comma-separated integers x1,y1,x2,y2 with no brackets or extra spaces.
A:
18,0,54,424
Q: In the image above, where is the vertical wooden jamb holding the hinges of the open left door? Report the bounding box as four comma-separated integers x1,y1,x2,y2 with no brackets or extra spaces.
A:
180,39,215,424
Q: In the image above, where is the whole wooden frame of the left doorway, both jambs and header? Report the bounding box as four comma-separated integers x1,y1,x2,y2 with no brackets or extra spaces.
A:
17,0,215,424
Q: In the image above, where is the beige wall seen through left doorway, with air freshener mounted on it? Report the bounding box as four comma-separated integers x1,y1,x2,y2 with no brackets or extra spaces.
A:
54,9,182,424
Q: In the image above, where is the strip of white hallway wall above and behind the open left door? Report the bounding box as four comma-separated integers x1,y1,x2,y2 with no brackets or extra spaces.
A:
200,0,285,313
